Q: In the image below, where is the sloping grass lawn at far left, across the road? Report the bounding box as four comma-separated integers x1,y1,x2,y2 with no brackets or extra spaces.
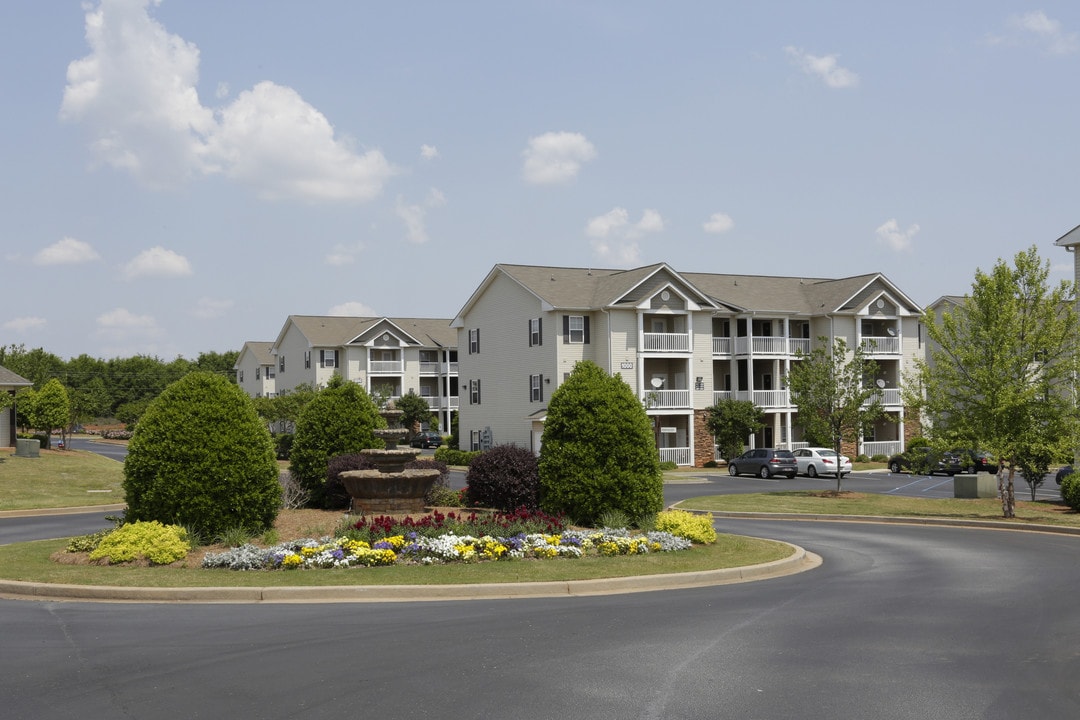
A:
0,448,124,511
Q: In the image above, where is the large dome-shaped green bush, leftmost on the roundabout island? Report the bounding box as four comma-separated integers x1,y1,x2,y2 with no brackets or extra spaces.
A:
123,372,281,536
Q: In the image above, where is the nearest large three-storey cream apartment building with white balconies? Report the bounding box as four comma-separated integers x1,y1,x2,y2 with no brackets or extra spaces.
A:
453,263,923,465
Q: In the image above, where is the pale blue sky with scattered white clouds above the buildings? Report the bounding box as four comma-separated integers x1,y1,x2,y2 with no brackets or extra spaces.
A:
0,0,1080,359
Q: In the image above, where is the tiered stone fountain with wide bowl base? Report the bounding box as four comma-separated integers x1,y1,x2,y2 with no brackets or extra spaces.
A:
339,408,440,515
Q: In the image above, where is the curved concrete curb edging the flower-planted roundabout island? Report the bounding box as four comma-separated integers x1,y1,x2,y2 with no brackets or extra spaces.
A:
0,543,822,603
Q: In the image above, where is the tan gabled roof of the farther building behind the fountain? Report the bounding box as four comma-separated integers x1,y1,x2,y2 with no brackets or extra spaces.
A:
272,315,458,349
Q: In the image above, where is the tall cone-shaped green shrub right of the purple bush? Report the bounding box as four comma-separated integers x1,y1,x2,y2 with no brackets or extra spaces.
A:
539,361,663,525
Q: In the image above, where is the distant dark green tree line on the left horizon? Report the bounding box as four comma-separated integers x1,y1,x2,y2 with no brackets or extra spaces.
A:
0,344,240,424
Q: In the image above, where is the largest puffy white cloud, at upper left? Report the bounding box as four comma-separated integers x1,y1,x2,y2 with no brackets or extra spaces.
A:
60,0,396,202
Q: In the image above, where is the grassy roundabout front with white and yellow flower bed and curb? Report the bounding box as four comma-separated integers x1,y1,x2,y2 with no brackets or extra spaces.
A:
0,507,818,602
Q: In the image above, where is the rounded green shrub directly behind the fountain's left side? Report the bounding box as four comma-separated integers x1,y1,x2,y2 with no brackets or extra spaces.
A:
289,375,387,507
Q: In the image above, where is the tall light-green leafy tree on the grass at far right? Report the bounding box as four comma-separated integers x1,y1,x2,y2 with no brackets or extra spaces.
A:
919,246,1080,517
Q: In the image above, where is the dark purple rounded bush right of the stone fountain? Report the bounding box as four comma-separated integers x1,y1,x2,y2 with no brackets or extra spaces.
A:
465,445,540,513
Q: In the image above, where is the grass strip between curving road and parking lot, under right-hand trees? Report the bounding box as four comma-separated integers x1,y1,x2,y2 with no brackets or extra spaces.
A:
679,490,1080,527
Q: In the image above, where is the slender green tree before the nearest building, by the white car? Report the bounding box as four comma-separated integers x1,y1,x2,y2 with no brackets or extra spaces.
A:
787,337,883,492
